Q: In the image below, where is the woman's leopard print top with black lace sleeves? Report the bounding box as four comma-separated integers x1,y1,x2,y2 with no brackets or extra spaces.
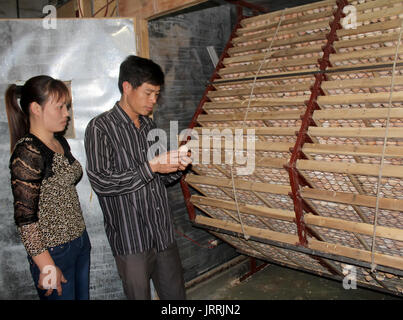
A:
10,134,85,256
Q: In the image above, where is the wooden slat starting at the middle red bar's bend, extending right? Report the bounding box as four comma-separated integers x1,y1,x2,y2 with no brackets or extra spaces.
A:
297,160,403,178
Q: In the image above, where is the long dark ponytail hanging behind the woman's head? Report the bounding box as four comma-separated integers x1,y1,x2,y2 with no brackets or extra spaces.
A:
5,84,29,152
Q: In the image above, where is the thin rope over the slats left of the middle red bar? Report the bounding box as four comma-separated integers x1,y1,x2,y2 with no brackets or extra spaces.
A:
230,8,287,240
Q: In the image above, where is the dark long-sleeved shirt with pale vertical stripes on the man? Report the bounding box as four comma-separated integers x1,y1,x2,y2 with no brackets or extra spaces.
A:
85,103,181,256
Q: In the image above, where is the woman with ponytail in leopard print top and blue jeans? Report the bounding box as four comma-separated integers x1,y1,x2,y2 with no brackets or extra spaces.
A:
6,75,91,300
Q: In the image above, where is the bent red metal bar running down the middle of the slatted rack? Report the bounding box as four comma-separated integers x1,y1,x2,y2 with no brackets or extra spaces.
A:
285,0,348,246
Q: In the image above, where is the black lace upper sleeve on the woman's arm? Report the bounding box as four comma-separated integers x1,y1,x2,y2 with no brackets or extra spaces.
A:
10,140,44,227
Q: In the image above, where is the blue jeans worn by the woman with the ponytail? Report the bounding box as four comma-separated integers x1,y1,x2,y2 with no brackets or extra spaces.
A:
28,230,91,300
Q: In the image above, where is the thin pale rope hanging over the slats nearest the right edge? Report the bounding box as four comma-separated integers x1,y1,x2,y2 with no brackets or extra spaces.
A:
371,22,403,273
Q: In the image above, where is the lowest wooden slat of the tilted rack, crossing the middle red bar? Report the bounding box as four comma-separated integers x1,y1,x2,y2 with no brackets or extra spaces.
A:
195,215,403,269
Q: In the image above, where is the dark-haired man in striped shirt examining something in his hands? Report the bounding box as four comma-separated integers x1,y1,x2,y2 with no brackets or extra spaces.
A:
85,56,190,300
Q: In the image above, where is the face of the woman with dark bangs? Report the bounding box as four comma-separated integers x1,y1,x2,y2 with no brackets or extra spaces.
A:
40,97,69,132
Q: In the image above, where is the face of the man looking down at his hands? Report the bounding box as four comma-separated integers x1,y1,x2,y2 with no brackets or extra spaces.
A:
125,82,161,116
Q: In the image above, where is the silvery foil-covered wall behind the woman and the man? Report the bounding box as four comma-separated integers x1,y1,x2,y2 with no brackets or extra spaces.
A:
0,19,136,299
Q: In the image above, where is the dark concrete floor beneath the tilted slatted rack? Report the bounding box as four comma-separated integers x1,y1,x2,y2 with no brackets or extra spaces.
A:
187,261,403,300
